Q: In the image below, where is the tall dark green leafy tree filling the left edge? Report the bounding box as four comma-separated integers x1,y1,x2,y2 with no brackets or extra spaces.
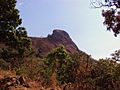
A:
0,0,31,66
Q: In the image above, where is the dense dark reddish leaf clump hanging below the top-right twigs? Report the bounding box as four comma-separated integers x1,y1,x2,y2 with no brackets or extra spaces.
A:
102,9,120,36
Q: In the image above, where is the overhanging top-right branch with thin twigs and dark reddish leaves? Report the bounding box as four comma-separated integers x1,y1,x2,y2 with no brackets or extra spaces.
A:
91,0,120,37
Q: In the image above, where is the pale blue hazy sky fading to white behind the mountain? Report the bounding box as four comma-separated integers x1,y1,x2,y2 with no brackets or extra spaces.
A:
17,0,120,59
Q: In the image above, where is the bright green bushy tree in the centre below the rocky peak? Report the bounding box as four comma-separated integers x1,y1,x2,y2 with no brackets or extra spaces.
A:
45,46,74,84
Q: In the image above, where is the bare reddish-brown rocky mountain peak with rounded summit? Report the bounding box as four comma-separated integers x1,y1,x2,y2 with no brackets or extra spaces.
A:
30,30,80,55
